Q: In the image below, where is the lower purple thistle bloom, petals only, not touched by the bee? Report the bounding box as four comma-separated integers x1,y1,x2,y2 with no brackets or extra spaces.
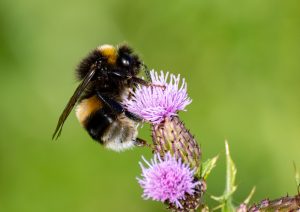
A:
137,152,200,208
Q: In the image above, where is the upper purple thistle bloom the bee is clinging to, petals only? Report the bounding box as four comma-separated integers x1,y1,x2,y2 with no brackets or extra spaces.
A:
124,70,192,124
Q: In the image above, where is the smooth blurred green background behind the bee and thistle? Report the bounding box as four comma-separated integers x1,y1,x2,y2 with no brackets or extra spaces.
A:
0,0,300,212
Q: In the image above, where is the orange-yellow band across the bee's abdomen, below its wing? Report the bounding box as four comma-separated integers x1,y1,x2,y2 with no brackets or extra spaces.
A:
76,96,102,125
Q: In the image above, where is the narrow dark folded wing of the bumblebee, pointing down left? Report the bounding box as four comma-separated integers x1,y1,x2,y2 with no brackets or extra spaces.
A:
52,67,96,139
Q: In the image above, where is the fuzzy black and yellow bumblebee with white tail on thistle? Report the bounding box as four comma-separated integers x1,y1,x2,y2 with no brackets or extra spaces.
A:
52,45,149,151
